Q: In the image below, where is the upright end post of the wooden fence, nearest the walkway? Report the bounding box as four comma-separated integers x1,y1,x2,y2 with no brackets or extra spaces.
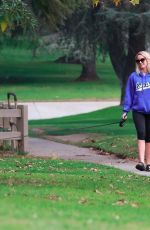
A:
16,105,28,152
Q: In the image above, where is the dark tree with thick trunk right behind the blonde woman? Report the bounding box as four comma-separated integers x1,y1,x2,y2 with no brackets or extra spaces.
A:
107,0,150,103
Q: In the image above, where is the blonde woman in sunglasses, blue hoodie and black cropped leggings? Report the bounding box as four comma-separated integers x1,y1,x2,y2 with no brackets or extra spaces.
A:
122,51,150,171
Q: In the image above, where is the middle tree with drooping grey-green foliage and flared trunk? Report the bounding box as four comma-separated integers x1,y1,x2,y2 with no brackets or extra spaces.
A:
61,1,102,81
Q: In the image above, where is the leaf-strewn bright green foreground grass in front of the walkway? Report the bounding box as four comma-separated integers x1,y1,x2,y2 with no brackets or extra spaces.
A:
0,158,150,230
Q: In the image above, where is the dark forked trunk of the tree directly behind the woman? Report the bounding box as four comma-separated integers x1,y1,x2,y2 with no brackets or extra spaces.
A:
108,13,146,104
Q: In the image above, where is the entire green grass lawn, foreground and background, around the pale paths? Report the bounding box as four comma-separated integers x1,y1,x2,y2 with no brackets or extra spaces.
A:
0,45,150,230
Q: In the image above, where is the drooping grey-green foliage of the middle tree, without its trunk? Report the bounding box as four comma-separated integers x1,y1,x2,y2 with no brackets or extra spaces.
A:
60,2,98,63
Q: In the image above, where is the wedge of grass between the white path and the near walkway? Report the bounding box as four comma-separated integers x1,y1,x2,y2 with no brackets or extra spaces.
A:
29,106,137,158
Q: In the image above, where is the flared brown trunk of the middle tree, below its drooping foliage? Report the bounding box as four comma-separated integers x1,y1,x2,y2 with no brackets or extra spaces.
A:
77,62,99,81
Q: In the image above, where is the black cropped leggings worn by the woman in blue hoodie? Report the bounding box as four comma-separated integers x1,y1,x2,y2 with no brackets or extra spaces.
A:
132,111,150,142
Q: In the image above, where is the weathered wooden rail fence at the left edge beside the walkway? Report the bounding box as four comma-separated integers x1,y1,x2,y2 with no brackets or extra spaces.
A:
0,105,28,152
